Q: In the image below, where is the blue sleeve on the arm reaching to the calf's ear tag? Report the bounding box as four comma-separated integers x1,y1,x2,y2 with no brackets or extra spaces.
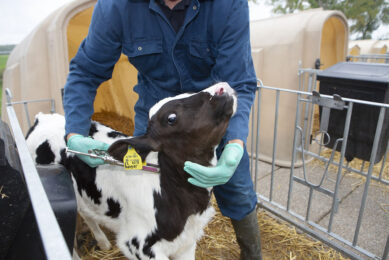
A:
63,0,121,136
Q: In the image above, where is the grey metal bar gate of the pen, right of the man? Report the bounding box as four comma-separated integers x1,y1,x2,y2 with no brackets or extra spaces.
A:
251,69,389,259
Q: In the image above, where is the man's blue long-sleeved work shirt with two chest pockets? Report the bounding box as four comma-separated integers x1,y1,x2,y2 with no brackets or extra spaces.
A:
64,0,256,142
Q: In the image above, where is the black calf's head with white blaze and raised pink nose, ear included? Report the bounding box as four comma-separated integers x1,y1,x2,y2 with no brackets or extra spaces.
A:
108,82,237,166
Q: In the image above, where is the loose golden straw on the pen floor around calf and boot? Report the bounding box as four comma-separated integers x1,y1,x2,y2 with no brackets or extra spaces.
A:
77,199,347,260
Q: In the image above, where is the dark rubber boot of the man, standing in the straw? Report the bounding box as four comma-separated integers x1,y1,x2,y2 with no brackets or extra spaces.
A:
231,210,262,260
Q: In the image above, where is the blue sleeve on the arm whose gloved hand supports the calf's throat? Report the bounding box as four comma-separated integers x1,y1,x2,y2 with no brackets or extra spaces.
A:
212,0,256,142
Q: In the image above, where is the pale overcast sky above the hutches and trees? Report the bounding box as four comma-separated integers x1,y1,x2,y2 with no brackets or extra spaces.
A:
0,0,389,45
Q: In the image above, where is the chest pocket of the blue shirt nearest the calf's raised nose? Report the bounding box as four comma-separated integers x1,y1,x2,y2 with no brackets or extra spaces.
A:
189,40,215,79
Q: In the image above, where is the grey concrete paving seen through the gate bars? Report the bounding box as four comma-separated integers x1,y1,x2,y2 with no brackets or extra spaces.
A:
252,161,389,259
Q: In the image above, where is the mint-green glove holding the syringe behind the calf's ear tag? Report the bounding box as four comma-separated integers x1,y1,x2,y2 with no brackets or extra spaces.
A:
67,135,109,168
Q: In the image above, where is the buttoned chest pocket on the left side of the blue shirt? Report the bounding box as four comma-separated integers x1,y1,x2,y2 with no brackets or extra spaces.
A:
123,39,163,78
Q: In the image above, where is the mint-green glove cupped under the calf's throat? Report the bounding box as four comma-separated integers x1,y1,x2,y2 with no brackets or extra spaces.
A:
184,143,243,188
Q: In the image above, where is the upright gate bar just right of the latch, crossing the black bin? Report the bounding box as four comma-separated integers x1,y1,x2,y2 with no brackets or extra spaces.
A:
328,102,353,232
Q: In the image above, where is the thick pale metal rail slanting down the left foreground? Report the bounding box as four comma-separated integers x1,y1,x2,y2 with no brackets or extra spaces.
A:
6,90,71,260
